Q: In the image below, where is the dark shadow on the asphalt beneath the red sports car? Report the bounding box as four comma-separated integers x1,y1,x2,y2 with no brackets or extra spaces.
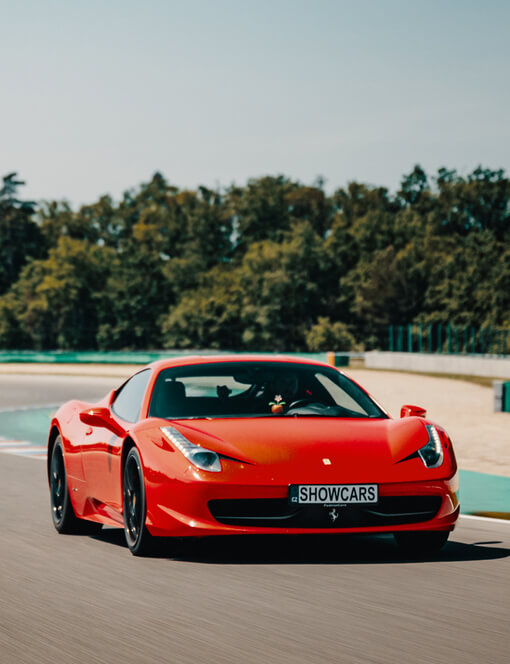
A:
94,528,510,565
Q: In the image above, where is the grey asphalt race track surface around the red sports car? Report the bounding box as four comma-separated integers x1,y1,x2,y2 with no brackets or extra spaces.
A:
0,375,510,664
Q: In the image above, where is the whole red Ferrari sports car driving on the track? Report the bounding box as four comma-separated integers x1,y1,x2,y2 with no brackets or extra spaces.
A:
48,355,459,555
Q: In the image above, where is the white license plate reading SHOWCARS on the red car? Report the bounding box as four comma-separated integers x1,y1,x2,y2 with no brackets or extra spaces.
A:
289,484,379,506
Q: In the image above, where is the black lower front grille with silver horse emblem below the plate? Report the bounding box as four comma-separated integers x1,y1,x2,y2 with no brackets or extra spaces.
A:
209,496,442,528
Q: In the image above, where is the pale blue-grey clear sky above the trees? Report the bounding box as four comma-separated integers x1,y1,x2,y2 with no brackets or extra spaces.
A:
0,0,510,206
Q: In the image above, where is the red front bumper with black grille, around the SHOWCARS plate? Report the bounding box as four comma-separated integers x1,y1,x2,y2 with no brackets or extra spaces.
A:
146,473,460,537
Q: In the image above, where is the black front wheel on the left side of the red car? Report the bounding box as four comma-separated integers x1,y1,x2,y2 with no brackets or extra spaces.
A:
122,447,154,556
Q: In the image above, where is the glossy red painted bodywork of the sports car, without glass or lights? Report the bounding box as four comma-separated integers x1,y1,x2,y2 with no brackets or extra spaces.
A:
48,355,459,536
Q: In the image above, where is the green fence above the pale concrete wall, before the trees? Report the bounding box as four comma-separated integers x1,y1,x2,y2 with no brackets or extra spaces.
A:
388,323,510,355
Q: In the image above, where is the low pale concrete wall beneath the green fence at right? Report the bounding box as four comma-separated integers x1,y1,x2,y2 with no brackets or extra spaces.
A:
365,351,510,380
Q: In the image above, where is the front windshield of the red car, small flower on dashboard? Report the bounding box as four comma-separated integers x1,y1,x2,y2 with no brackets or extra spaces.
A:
149,361,387,419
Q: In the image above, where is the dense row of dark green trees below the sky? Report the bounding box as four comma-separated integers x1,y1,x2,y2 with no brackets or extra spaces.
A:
0,166,510,351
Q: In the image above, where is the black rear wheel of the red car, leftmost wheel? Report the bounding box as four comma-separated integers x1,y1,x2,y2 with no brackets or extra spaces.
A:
49,436,102,535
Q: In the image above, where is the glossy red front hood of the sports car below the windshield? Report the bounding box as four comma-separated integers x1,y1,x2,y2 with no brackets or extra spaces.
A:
171,417,436,477
